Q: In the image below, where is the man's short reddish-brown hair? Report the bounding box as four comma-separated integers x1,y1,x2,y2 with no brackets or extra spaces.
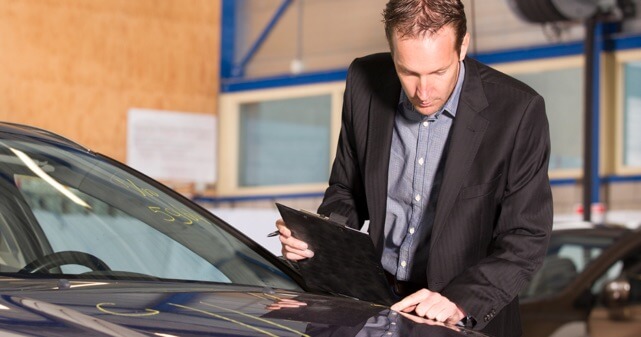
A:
383,0,467,54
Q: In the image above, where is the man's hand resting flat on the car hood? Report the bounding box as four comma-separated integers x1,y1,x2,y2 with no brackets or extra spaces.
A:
391,289,465,324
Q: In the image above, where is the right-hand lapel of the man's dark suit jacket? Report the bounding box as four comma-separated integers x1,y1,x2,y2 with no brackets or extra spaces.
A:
430,59,489,247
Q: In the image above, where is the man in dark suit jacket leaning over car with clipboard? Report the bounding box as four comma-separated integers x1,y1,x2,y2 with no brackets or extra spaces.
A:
277,0,552,336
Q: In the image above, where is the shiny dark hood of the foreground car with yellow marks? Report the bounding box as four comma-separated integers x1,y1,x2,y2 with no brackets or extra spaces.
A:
0,279,481,337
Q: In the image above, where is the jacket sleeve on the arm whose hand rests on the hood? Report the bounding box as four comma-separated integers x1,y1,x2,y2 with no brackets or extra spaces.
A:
440,95,552,329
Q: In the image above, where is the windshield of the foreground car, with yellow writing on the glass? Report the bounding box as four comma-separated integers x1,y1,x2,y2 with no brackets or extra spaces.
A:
0,130,300,290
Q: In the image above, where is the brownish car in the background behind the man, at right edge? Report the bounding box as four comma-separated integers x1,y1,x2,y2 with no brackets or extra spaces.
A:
520,225,641,337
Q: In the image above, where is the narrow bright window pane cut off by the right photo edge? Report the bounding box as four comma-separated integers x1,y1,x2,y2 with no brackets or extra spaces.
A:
623,62,641,166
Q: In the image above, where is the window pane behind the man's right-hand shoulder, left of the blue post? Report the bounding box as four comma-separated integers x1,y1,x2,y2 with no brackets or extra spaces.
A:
513,67,583,170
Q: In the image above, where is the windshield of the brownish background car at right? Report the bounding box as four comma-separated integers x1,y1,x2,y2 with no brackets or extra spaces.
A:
519,229,621,299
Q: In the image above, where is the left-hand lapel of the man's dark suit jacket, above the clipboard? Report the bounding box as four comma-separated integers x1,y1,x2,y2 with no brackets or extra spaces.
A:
364,72,401,247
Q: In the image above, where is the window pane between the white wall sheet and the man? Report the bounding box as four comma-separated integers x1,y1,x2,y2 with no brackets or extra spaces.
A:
238,94,332,187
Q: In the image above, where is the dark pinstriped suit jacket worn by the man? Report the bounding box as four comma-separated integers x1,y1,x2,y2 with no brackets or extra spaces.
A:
318,53,552,337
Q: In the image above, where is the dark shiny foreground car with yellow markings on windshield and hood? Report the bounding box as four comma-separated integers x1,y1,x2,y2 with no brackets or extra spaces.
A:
0,123,480,337
